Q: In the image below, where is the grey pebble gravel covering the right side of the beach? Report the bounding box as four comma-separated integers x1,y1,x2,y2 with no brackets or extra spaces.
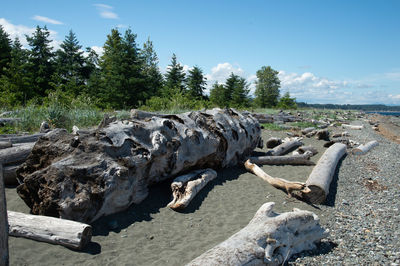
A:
288,117,400,265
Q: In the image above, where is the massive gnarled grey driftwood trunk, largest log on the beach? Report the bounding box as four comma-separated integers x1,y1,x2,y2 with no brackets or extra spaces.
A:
17,109,261,223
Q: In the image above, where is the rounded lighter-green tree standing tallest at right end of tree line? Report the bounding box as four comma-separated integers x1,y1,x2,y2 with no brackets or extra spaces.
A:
254,66,281,108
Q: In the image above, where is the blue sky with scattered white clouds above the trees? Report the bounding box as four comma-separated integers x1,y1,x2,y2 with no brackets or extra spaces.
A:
0,0,400,105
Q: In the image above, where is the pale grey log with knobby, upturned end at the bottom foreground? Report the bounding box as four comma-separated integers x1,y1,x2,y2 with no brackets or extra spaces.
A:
187,202,328,266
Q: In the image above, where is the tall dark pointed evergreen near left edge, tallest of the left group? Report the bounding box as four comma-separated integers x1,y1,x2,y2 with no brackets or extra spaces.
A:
26,26,54,97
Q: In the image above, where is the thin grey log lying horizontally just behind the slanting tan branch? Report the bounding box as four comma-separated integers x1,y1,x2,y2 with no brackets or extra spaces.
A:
250,152,315,165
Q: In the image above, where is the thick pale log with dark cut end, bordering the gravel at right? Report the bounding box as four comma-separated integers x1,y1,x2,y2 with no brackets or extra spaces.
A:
305,143,346,204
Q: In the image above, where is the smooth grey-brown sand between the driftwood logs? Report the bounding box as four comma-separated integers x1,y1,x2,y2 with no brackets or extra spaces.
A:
2,125,372,265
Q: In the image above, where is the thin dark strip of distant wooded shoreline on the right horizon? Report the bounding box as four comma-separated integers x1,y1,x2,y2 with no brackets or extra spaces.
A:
297,102,400,111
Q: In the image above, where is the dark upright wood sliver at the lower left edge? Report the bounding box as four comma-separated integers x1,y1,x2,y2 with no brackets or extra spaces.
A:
0,162,9,266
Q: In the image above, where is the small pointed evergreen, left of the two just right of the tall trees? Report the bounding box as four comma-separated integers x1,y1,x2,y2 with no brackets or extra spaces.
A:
164,54,185,96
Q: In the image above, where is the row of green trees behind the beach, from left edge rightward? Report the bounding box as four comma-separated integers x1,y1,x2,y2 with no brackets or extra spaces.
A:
0,25,296,110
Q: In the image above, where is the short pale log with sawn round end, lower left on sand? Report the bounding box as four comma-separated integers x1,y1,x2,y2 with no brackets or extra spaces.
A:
7,211,92,250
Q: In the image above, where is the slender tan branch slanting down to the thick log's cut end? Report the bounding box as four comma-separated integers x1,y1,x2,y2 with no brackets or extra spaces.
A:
244,160,309,196
